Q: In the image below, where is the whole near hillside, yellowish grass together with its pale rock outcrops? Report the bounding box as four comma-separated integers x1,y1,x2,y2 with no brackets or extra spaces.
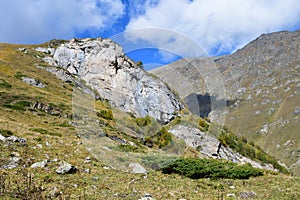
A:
0,40,300,199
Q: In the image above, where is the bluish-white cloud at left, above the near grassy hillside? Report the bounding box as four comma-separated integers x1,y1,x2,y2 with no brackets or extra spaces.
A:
0,0,125,43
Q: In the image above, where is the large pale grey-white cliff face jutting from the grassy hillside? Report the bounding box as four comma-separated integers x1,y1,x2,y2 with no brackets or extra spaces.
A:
37,38,183,123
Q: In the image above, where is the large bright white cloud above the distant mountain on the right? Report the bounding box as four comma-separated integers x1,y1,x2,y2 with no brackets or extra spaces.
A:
126,0,300,54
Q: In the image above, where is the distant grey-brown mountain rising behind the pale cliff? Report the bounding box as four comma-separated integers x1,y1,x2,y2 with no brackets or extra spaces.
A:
151,30,300,175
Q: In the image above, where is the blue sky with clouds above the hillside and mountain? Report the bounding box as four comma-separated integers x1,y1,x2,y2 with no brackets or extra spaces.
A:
0,0,300,69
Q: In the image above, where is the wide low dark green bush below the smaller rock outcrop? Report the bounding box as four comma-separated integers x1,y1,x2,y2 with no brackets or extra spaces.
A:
161,158,263,179
